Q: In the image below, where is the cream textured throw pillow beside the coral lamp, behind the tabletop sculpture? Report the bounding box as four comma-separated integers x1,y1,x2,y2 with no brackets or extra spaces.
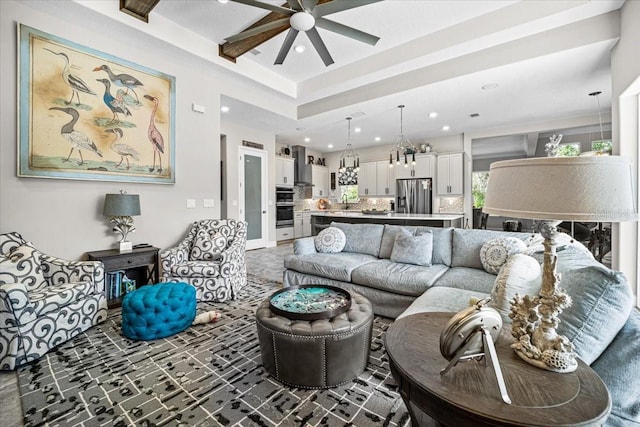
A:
489,254,542,323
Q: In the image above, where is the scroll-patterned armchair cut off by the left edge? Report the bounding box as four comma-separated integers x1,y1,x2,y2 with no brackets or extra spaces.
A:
0,233,107,370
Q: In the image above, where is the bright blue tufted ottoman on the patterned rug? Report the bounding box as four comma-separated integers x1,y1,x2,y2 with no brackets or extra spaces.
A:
122,283,196,340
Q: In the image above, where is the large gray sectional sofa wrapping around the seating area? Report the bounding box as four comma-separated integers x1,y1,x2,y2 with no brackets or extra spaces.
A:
284,223,640,426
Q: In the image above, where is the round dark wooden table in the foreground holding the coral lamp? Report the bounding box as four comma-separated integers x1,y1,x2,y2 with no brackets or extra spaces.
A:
385,313,611,427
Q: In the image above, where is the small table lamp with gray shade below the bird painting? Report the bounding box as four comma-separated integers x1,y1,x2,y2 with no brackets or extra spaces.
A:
102,190,140,252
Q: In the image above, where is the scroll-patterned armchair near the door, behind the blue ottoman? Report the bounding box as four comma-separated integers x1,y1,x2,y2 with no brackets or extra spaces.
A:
160,219,247,302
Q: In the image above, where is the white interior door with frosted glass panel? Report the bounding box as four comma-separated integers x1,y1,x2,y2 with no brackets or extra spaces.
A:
238,147,268,249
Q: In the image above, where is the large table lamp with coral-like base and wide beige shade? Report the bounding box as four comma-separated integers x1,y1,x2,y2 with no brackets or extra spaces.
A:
483,156,638,372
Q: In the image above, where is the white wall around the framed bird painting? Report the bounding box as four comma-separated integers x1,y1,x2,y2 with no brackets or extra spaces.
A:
0,1,282,259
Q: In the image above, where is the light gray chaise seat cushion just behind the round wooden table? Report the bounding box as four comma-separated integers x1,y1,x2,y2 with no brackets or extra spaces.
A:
396,287,487,320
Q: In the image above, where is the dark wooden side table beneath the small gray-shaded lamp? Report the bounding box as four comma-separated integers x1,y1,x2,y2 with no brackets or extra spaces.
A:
87,246,160,308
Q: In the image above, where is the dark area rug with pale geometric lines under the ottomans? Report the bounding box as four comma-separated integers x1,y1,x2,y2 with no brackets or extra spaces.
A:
18,277,409,427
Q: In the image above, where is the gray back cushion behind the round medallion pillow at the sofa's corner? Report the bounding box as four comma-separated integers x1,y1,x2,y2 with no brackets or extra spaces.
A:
451,228,530,269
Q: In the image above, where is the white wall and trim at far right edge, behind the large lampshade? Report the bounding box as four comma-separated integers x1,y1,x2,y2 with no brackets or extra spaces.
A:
611,1,640,306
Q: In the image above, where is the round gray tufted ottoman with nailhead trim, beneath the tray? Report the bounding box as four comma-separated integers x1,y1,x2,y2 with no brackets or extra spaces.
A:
256,292,373,388
